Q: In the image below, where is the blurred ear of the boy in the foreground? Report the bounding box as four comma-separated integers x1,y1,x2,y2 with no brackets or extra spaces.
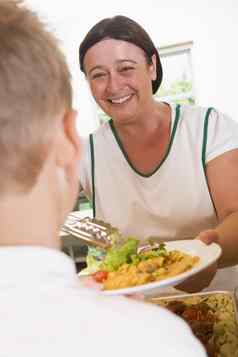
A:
57,110,80,167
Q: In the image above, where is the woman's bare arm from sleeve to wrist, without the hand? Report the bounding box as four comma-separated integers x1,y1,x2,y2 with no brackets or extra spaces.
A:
206,149,238,267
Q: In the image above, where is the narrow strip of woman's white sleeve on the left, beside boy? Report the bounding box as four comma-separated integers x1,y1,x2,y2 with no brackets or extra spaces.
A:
78,137,92,199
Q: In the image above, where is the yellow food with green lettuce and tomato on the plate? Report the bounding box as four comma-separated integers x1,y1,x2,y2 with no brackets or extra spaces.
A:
82,237,199,290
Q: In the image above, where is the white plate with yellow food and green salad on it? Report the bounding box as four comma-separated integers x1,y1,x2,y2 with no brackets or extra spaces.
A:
79,238,221,296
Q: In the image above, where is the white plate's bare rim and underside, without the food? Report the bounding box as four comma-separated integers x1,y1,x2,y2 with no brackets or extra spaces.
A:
79,239,222,296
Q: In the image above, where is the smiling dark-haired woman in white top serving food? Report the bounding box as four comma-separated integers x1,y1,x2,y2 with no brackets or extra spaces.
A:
79,16,238,291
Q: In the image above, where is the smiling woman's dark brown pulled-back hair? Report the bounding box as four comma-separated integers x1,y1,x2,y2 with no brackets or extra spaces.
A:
79,15,163,94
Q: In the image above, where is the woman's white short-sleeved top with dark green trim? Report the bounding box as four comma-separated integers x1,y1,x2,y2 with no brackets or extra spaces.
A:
79,104,238,288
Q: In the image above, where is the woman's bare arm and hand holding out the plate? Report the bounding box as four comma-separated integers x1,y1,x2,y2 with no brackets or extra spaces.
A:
177,149,238,293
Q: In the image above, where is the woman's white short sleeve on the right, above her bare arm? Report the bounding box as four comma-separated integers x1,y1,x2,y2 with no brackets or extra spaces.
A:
206,109,238,163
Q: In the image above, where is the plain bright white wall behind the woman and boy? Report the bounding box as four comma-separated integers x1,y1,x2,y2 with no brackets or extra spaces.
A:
27,0,238,134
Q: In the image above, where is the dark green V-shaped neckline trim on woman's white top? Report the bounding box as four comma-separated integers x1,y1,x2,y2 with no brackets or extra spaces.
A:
109,105,180,177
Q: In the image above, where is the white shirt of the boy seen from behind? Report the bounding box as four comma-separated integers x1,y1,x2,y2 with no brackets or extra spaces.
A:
0,247,205,357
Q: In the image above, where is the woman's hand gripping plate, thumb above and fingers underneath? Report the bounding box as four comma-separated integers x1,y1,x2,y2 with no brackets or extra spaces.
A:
176,229,218,293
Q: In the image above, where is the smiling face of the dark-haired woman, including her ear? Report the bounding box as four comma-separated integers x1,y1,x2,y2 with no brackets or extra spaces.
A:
84,39,156,123
